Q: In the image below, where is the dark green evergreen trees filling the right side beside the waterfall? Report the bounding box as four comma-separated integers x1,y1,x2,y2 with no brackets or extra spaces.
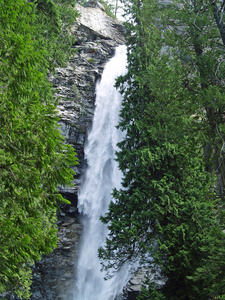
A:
99,0,225,300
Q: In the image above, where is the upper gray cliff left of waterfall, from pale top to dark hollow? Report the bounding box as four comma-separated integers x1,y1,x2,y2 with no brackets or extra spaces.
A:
50,1,124,194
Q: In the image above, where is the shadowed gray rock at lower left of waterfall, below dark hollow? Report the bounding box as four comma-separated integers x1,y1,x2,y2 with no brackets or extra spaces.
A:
31,216,81,300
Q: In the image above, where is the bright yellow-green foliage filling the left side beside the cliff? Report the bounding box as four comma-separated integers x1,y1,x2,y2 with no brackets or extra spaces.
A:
0,0,77,299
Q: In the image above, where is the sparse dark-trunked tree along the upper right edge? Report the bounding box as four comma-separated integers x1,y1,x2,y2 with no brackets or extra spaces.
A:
167,1,225,199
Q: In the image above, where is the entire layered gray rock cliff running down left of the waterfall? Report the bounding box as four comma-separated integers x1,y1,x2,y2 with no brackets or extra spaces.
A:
31,4,124,300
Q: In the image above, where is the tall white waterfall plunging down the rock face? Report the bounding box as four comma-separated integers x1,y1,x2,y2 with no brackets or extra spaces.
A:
74,46,129,300
